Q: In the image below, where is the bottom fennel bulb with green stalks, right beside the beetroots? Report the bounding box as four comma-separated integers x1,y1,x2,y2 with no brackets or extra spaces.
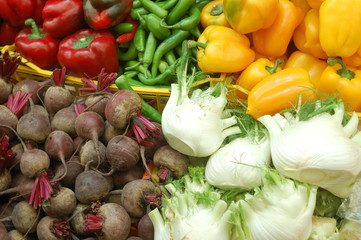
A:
148,167,231,240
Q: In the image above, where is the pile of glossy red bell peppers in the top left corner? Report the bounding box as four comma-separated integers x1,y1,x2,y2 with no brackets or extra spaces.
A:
0,0,138,78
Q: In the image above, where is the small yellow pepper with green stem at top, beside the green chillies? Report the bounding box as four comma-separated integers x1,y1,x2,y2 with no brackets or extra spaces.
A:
201,0,231,28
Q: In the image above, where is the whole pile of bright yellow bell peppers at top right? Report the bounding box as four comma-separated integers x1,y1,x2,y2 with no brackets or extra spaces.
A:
196,0,361,118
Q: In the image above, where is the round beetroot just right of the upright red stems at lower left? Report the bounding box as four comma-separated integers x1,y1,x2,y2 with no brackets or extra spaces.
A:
43,187,77,218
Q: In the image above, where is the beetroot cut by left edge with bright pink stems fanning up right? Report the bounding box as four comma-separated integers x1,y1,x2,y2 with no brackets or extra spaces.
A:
0,91,32,139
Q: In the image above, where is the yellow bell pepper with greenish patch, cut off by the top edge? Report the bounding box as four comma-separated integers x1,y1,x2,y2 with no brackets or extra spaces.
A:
223,0,279,34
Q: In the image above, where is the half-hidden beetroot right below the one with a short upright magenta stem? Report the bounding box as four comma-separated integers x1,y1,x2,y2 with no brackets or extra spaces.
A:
51,105,77,138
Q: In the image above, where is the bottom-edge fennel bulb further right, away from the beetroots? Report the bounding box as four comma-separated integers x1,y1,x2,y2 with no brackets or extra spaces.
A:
238,170,317,240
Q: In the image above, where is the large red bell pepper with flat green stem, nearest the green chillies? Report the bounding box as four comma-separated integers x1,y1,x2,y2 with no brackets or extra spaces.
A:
58,29,119,78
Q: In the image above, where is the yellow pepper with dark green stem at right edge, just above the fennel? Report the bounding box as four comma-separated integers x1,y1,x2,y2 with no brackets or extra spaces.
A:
316,58,361,111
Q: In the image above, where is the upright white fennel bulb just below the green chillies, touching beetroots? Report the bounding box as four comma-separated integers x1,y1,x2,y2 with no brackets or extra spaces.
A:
162,67,239,157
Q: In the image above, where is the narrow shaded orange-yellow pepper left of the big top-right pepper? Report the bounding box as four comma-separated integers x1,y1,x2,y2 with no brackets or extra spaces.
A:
293,9,327,59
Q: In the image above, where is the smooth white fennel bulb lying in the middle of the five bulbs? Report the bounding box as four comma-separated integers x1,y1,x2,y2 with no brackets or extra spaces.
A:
205,137,271,190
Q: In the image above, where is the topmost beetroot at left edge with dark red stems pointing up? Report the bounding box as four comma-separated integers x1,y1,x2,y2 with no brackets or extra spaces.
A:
0,50,21,104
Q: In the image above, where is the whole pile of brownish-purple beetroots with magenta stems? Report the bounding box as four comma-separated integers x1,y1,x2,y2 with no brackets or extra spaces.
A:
0,52,189,240
